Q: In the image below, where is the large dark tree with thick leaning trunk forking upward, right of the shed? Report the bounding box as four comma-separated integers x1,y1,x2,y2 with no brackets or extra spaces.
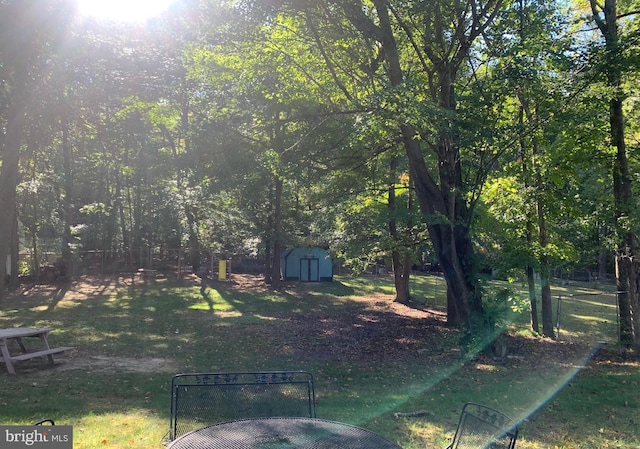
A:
292,0,508,325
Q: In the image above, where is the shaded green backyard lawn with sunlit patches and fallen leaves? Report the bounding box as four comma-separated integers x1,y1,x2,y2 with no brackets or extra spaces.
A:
0,276,640,449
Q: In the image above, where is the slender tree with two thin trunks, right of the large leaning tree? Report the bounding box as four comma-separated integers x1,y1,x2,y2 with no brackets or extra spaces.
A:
492,1,575,337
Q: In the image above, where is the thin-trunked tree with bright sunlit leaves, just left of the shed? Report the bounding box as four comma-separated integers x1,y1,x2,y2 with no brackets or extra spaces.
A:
194,4,360,286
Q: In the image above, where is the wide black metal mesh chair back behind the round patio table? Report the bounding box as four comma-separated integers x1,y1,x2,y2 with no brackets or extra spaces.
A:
168,371,317,441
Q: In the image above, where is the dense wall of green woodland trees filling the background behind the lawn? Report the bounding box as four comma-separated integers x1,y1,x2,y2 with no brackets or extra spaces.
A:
0,0,640,344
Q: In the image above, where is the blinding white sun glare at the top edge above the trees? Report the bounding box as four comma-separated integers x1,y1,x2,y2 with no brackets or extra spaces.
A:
78,0,175,22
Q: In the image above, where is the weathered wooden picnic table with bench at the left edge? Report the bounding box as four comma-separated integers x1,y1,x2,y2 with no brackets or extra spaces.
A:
0,327,73,374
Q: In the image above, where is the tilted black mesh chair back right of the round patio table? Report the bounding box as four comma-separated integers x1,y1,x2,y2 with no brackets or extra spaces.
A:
447,402,518,449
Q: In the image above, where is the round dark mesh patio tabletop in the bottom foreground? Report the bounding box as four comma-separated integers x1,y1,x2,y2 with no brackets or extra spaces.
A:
168,418,402,449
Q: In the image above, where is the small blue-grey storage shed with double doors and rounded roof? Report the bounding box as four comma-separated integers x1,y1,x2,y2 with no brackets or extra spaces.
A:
280,246,333,282
